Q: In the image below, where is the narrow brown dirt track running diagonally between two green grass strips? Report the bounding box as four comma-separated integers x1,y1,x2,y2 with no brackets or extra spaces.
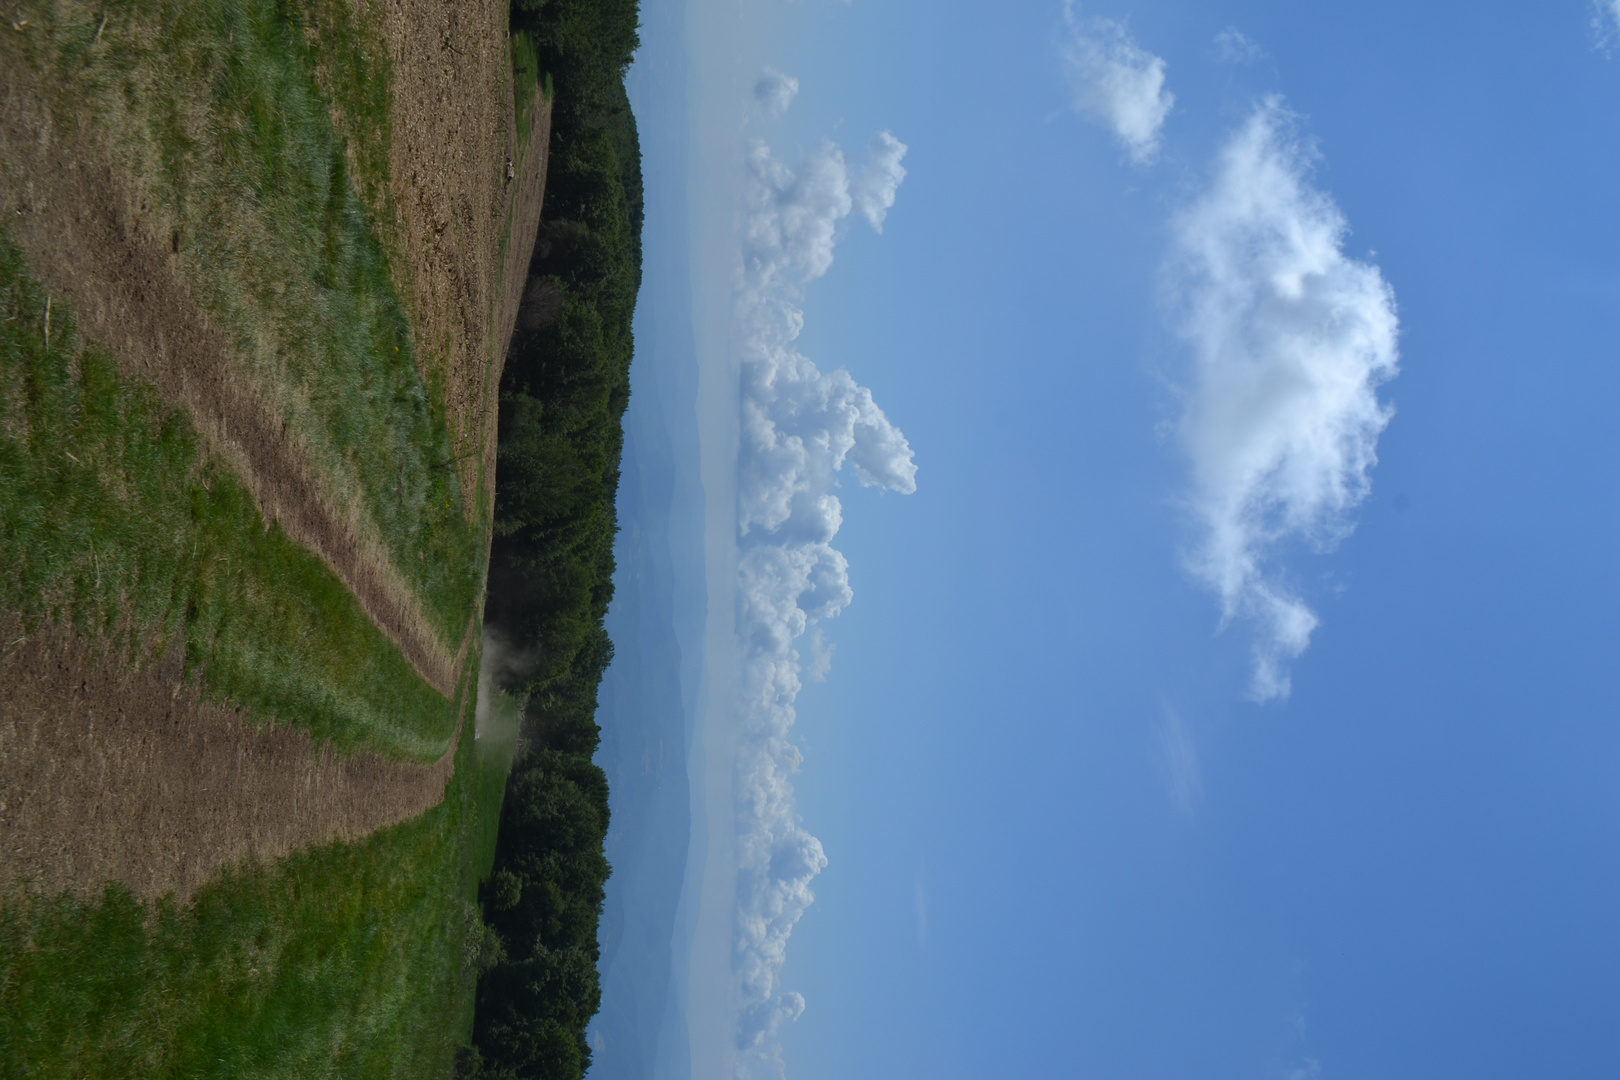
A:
0,65,458,696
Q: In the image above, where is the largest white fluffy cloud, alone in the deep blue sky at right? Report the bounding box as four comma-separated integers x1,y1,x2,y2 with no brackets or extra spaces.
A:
1170,99,1398,701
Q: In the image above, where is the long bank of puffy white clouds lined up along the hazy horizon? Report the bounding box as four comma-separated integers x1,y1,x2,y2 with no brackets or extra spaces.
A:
734,71,917,1080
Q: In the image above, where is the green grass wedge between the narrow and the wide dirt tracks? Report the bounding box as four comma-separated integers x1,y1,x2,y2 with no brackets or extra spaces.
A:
0,235,455,761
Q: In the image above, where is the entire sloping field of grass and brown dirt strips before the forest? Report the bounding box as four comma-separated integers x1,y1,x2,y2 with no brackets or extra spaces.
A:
0,0,551,1077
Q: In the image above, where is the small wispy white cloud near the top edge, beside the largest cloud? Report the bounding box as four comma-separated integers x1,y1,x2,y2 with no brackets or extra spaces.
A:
1063,0,1176,165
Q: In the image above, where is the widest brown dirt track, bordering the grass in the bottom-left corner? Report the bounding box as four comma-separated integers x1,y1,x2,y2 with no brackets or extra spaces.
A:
0,619,465,902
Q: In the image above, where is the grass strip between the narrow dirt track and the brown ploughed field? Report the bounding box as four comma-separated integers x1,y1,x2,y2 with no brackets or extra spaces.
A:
8,0,486,653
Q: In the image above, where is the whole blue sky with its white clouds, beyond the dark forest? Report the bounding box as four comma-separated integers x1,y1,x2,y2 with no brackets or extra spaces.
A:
596,0,1620,1080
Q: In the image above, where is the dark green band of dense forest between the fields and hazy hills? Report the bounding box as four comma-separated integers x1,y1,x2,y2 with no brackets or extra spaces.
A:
460,0,642,1080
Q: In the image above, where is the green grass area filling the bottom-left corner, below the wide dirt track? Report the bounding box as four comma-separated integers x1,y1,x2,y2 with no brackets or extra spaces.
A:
0,670,515,1080
